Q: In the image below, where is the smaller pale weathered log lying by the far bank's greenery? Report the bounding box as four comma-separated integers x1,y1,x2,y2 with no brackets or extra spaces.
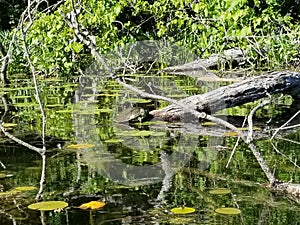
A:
162,49,246,75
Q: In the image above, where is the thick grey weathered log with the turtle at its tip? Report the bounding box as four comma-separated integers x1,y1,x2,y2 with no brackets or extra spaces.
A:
150,71,300,121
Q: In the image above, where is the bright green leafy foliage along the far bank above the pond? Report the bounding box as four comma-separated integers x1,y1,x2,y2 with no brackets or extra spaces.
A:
5,0,300,77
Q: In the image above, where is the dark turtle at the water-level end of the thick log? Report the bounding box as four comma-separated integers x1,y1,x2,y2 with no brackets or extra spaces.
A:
115,107,147,123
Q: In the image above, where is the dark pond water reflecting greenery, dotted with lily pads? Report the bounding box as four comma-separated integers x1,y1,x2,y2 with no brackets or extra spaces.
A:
0,74,300,225
